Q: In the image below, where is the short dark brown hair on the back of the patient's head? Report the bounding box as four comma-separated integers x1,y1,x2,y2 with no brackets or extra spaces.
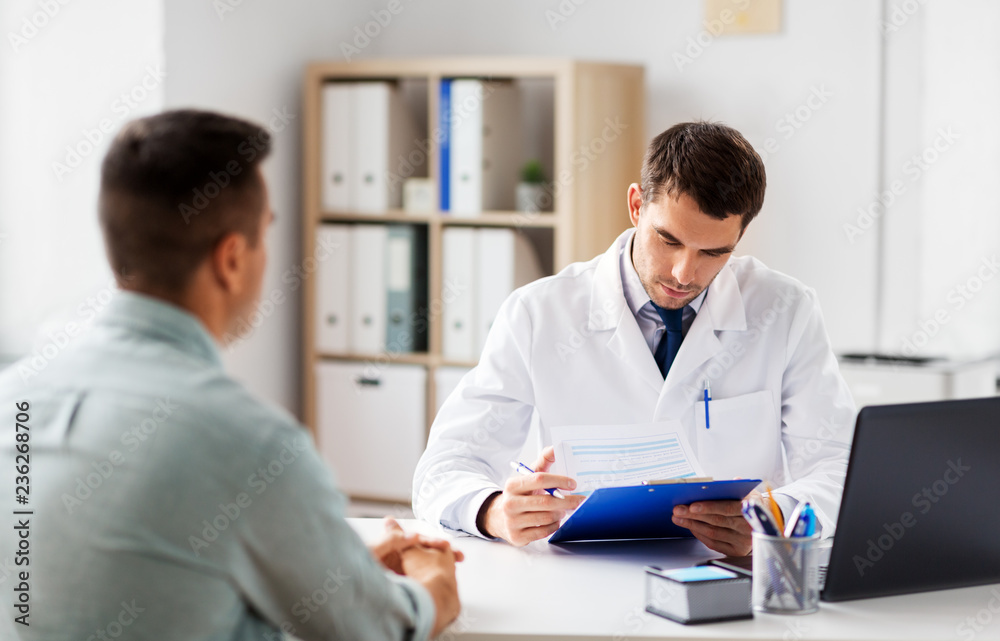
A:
98,110,271,297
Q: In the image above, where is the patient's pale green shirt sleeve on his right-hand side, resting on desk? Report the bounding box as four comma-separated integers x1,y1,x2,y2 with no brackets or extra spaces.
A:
226,427,435,641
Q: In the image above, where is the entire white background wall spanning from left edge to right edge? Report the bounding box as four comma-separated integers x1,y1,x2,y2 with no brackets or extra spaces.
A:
0,0,1000,411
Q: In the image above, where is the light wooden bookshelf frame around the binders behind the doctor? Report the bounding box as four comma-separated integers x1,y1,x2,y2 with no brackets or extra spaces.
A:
302,57,646,501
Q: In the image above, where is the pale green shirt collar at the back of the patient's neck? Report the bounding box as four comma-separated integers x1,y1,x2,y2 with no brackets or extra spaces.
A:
97,290,222,367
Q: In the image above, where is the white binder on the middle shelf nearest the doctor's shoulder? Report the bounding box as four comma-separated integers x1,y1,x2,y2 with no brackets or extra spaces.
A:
475,228,545,358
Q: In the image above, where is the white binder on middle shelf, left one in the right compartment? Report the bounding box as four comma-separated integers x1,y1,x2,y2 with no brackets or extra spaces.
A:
441,227,479,362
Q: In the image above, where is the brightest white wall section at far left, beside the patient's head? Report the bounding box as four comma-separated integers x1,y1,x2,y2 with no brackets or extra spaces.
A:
0,0,163,368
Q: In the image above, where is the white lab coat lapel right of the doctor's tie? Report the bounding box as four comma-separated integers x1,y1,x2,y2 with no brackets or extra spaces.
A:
663,263,747,393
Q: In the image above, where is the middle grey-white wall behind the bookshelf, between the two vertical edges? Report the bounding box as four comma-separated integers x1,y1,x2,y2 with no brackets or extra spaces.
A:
165,0,878,410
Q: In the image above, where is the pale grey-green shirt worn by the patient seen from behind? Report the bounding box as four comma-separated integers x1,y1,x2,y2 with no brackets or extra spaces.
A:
0,292,434,641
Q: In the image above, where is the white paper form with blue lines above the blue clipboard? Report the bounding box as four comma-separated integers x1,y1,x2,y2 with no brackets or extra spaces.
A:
549,421,704,495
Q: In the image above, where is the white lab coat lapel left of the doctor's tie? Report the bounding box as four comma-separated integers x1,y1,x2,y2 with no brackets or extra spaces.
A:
588,229,664,393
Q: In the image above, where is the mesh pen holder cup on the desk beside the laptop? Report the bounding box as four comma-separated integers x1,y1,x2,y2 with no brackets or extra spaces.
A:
753,532,819,614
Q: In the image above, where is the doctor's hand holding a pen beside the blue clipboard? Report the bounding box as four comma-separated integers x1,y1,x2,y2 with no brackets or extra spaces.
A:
484,447,586,547
